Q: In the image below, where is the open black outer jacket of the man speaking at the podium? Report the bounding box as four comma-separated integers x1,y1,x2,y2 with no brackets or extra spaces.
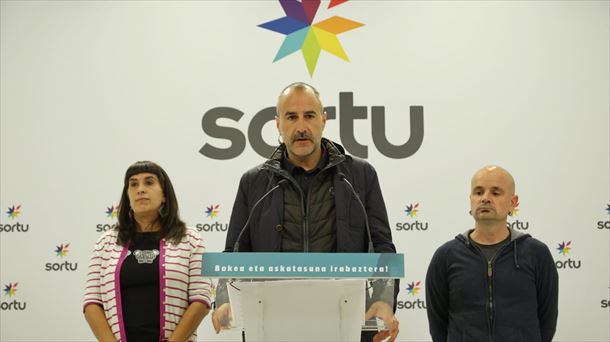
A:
225,139,396,253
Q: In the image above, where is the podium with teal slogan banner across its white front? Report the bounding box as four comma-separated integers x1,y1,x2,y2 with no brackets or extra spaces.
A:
202,253,404,342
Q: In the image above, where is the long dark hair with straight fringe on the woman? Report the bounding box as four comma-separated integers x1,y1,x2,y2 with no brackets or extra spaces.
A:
116,161,186,245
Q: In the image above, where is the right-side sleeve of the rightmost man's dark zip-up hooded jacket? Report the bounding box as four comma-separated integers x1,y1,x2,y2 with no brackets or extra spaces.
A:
536,245,559,342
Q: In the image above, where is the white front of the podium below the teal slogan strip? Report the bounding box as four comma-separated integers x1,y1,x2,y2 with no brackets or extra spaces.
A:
228,279,366,342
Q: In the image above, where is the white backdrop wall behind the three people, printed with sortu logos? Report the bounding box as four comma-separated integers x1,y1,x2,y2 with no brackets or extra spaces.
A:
0,1,610,341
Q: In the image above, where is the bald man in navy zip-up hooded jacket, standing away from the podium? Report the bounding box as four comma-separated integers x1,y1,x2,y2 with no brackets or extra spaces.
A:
426,166,558,342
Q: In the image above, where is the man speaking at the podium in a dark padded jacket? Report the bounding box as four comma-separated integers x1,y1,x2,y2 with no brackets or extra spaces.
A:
212,82,399,342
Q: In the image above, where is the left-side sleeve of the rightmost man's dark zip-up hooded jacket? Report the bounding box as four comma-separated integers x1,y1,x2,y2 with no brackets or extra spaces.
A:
426,248,449,342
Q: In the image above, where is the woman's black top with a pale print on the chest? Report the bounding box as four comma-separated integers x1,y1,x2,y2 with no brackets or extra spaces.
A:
121,233,161,342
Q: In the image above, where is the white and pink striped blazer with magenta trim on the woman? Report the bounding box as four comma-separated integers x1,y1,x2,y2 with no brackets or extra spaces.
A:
83,228,211,342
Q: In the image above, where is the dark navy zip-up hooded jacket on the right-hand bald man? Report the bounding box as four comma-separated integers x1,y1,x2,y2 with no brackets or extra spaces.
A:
426,229,558,342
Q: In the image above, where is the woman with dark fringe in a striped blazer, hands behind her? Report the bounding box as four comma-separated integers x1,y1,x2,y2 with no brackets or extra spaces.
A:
84,161,211,342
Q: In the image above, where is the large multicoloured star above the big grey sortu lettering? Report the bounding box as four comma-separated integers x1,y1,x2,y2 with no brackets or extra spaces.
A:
258,0,364,77
